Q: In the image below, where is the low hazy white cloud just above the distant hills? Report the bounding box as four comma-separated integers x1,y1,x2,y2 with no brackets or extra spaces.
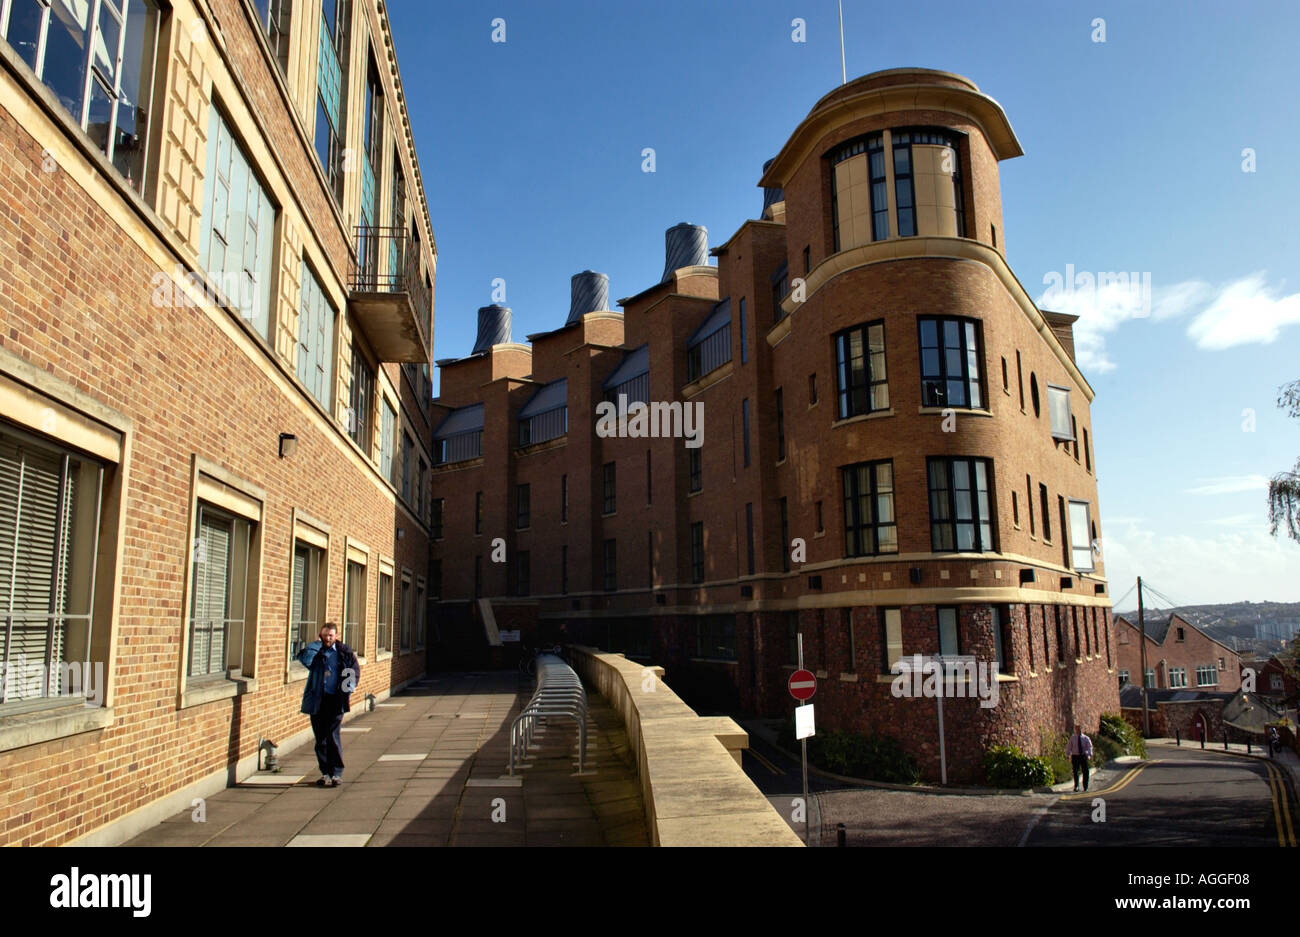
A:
1102,511,1300,608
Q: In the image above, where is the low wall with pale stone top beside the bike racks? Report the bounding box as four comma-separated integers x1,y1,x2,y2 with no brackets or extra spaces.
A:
568,645,803,846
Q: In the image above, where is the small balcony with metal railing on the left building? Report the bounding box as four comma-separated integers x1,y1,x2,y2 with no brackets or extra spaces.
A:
347,225,433,363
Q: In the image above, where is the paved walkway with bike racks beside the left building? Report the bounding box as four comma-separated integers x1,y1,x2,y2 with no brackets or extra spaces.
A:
126,672,649,846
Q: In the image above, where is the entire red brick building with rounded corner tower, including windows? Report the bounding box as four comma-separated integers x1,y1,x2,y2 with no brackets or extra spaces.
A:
433,69,1119,780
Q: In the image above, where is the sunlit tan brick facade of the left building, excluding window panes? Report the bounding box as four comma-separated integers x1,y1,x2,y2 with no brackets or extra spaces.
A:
0,0,434,845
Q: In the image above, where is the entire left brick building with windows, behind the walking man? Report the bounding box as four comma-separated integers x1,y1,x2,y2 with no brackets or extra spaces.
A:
0,0,436,845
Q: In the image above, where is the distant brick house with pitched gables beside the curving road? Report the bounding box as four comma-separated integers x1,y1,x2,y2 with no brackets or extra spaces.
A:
1115,613,1242,693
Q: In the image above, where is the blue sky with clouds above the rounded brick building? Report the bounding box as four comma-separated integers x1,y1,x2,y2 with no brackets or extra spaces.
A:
387,0,1300,604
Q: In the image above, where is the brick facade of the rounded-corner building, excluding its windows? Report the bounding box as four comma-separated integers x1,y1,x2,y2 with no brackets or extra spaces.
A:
433,69,1119,781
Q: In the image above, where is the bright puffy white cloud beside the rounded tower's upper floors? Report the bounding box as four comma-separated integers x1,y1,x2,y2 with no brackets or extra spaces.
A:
1037,265,1300,373
